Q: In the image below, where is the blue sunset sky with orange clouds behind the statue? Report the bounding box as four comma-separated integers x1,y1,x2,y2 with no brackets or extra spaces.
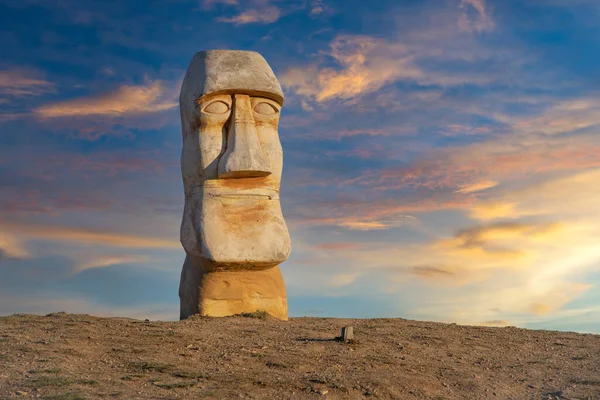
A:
0,0,600,333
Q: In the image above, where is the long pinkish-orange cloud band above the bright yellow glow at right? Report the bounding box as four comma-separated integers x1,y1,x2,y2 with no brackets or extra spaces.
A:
342,130,600,194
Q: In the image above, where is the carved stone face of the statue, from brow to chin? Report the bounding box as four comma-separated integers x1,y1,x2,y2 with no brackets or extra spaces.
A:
181,94,290,269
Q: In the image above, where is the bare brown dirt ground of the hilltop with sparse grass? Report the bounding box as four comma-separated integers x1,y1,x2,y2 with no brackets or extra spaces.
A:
0,313,600,400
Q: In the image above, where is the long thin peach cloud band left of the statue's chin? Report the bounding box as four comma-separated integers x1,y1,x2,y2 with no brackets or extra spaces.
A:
2,222,181,249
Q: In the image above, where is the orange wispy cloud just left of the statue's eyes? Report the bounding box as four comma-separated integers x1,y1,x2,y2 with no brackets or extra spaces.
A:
33,81,177,118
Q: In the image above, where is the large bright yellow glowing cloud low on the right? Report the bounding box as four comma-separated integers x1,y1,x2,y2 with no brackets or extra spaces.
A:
288,169,600,324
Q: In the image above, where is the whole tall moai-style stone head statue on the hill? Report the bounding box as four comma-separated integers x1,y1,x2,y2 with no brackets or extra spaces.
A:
179,50,290,320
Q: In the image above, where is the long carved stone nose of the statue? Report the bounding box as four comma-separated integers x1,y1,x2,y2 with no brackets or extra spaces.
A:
218,94,271,179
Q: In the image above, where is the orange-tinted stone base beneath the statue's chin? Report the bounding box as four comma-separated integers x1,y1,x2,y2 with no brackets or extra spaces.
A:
179,257,288,320
